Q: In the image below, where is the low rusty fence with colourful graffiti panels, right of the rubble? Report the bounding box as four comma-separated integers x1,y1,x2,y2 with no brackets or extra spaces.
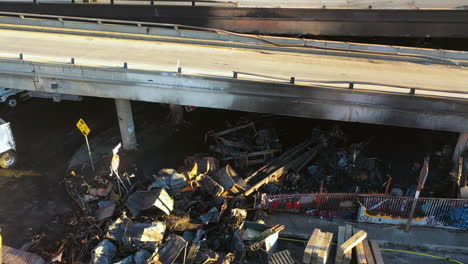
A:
262,193,468,229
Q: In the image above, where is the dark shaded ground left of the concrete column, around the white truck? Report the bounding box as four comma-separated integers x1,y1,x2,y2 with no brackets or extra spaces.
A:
0,99,120,247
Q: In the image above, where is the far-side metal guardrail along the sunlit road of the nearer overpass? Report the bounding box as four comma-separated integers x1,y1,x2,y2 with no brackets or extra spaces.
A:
0,10,468,68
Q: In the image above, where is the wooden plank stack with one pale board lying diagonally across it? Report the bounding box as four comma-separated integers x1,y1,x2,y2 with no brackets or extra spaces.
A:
335,225,384,264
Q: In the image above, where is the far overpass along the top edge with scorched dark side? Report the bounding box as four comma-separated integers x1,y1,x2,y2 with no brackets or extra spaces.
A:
0,0,468,38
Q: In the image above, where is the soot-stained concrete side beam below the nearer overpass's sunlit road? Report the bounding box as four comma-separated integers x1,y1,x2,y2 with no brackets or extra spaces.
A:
0,60,468,132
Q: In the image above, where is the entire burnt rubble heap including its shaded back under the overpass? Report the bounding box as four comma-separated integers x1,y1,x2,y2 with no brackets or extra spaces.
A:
56,123,458,264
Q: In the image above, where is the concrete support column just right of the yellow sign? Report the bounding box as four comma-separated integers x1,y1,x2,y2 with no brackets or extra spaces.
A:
115,99,137,150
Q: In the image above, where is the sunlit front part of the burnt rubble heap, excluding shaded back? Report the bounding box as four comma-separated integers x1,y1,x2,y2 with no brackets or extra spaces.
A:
64,148,300,264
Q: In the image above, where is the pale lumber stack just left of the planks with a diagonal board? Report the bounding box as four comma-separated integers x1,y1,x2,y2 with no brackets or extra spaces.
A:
303,228,333,264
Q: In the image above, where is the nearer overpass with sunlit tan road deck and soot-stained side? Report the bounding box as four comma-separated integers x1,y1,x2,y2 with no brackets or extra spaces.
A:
0,13,468,145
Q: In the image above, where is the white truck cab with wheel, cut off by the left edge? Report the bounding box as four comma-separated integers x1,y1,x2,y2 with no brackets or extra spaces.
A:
0,118,17,169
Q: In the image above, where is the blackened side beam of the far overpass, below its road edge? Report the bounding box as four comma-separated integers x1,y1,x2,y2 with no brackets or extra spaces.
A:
0,2,468,38
